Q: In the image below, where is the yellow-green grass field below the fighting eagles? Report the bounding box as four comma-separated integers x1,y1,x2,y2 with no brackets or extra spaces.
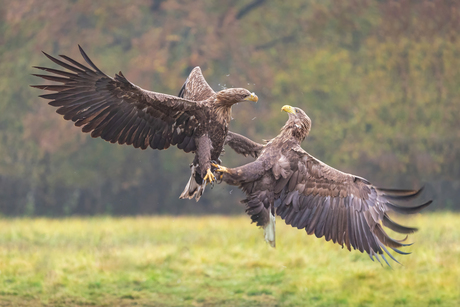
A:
0,213,460,306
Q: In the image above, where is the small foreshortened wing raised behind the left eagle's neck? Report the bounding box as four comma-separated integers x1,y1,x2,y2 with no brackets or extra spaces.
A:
177,66,216,101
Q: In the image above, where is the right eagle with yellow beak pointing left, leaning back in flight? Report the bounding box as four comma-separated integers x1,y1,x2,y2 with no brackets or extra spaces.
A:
214,105,431,265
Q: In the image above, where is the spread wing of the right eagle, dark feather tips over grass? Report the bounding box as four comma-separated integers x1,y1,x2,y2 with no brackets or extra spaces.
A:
273,146,431,263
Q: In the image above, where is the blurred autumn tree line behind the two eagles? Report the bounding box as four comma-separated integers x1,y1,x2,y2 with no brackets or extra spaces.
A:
0,0,460,216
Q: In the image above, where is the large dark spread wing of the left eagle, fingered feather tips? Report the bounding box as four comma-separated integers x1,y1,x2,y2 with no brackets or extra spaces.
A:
32,46,203,152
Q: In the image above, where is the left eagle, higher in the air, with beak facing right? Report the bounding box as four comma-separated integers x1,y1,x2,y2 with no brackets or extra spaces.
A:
31,46,258,201
